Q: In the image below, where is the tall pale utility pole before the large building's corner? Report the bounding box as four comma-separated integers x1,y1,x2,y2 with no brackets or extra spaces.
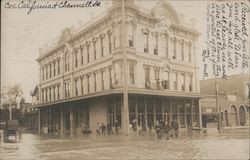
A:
122,0,129,135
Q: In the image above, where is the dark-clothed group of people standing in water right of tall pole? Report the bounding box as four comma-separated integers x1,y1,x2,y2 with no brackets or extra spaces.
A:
155,120,179,139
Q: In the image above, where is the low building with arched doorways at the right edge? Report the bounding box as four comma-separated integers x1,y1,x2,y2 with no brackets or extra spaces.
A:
200,74,250,127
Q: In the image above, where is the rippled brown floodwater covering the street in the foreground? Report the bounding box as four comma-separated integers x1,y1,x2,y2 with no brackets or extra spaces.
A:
0,129,249,160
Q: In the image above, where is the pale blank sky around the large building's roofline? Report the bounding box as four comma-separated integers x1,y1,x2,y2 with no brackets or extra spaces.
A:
1,0,249,102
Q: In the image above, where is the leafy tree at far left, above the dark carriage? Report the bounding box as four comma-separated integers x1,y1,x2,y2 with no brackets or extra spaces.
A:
1,83,23,108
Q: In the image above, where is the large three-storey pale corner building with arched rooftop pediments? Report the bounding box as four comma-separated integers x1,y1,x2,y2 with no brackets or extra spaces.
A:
37,0,201,134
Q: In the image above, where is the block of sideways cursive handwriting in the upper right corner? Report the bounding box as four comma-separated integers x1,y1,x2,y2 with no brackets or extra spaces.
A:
201,2,250,79
